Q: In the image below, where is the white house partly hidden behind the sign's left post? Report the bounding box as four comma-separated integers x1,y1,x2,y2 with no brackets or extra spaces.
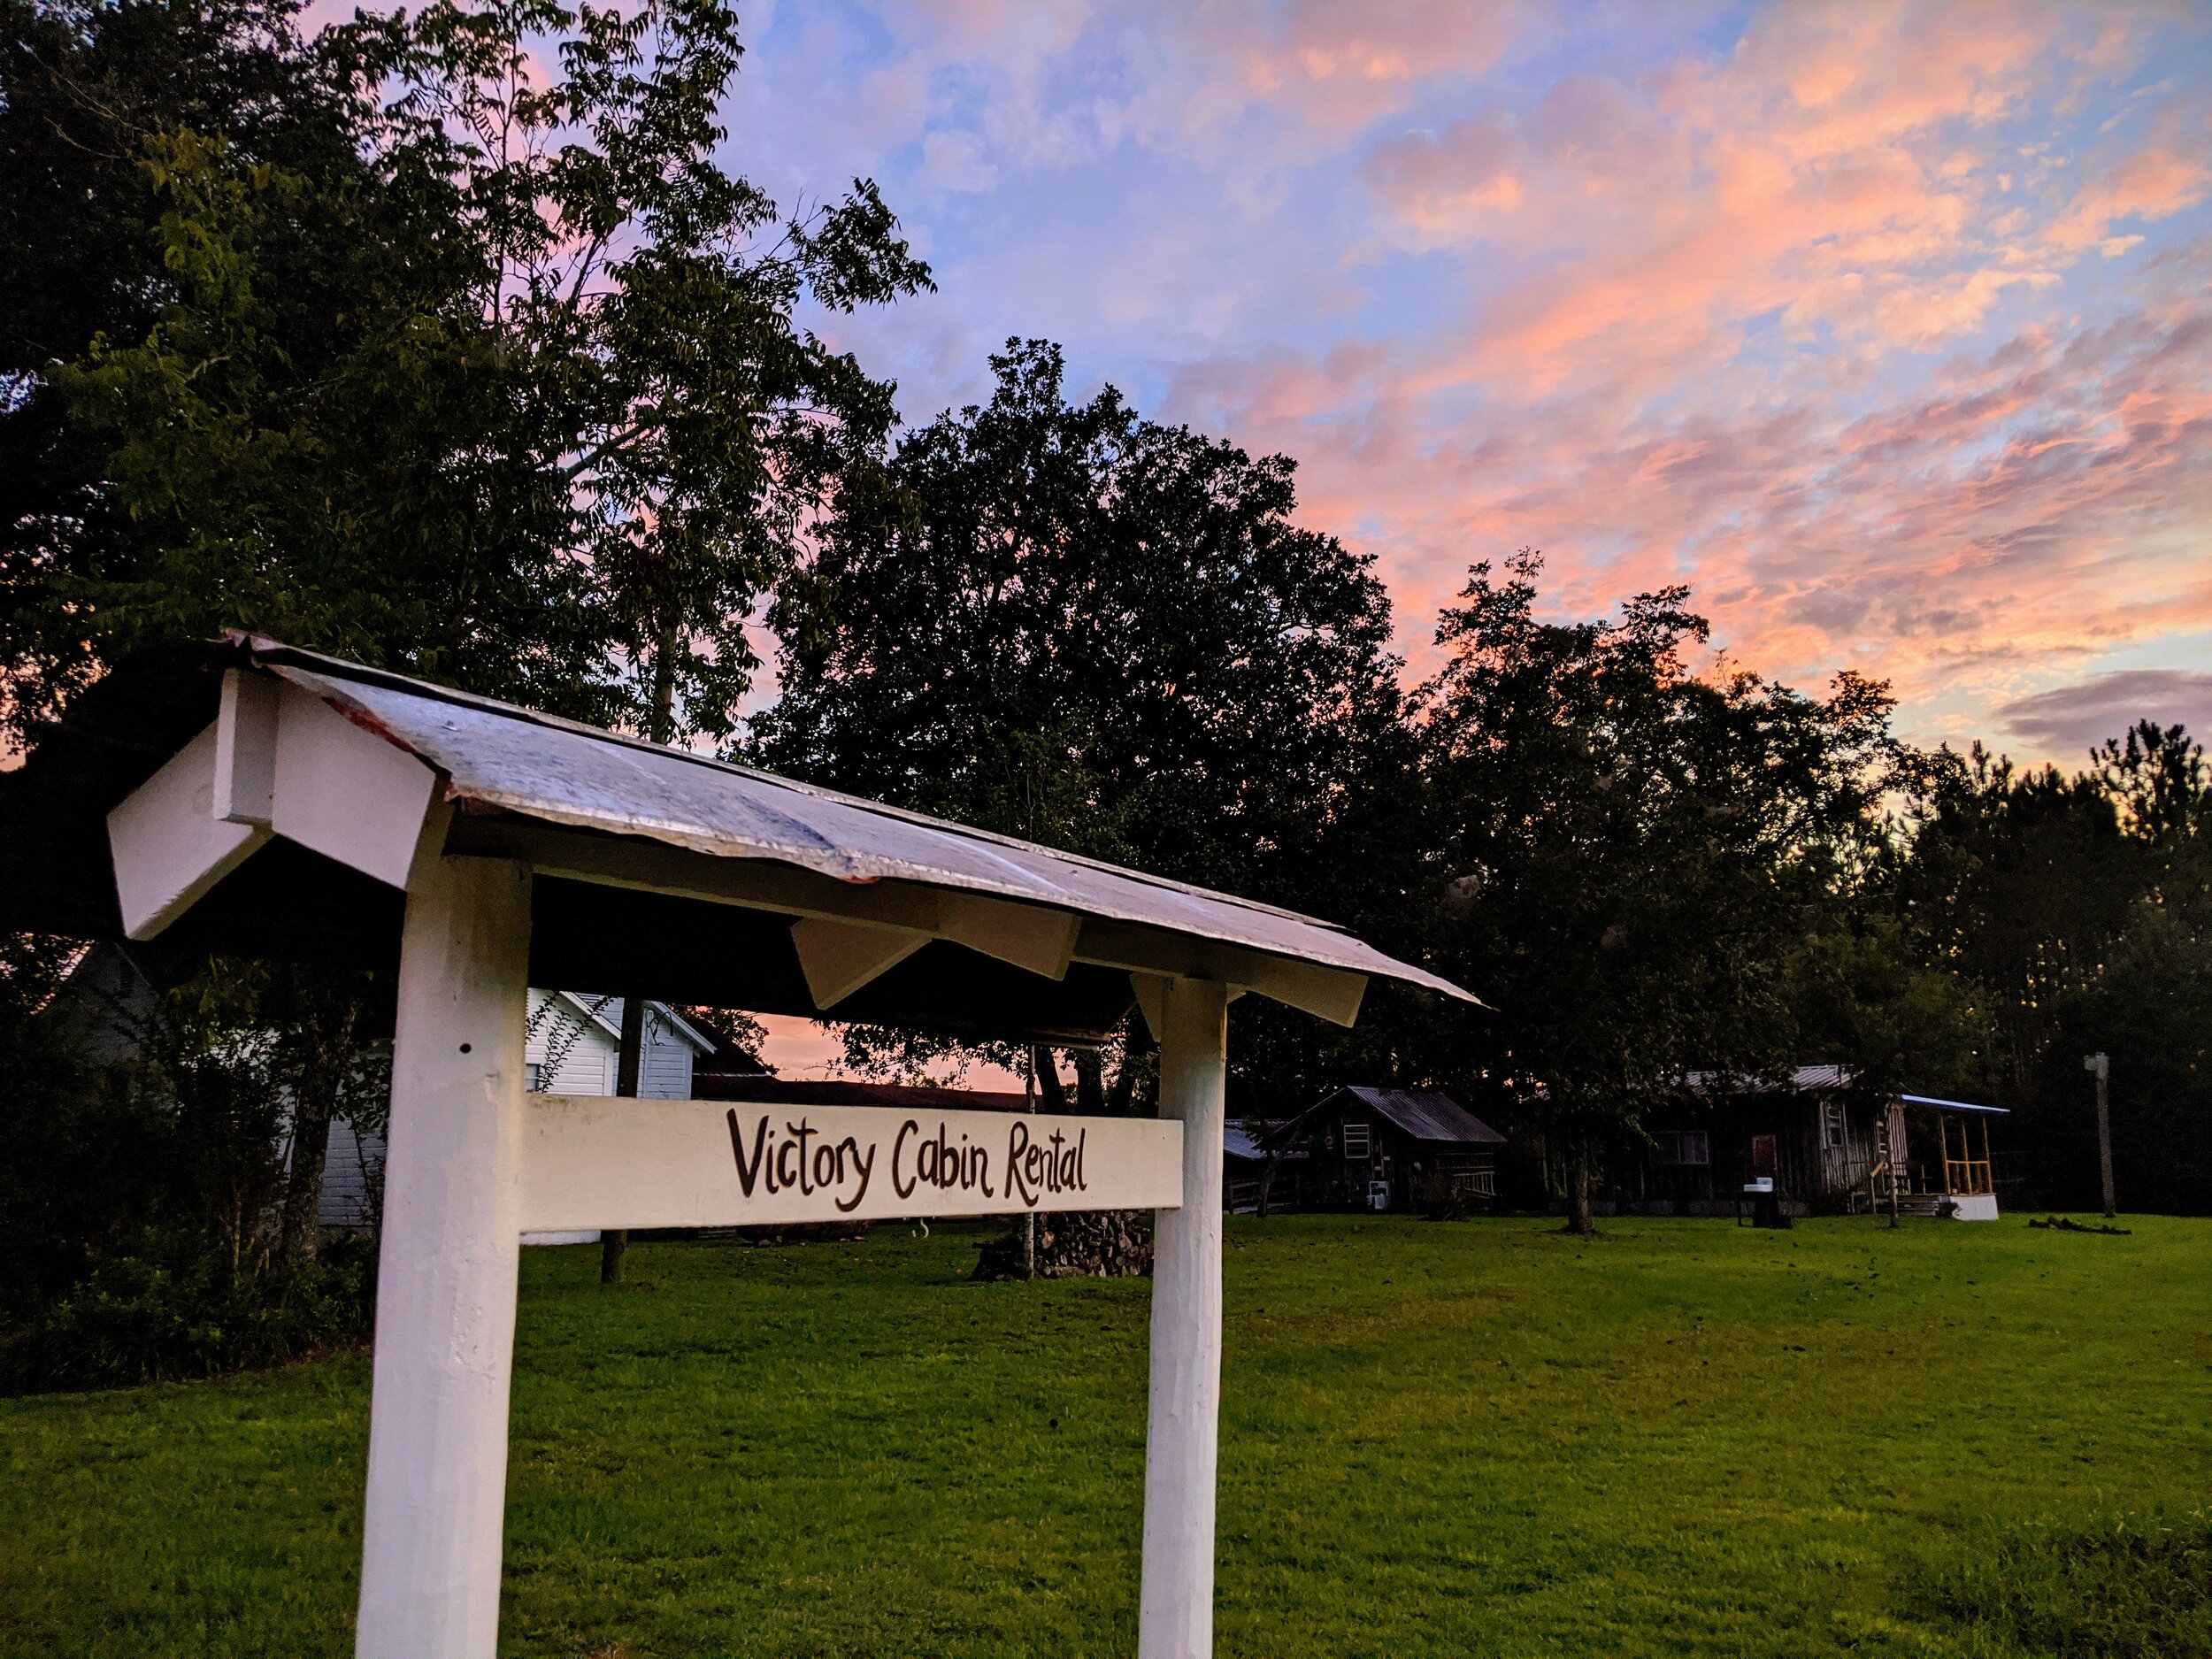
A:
321,991,715,1243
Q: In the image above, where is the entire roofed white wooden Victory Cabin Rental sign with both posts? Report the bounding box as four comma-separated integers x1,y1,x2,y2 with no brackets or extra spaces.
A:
26,640,1467,1659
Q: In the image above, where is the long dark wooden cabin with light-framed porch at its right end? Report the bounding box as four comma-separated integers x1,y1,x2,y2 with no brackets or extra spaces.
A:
1584,1066,2007,1221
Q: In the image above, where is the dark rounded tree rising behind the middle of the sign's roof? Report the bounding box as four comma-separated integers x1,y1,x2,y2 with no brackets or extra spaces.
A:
752,341,1409,1110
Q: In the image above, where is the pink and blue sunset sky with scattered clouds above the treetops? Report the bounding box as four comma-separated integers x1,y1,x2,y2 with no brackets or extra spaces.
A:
728,0,2212,764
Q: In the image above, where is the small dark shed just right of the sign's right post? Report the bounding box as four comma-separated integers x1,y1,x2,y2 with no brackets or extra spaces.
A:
1270,1087,1507,1210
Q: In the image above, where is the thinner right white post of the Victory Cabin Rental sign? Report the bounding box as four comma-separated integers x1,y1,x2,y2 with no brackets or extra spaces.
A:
1137,980,1228,1659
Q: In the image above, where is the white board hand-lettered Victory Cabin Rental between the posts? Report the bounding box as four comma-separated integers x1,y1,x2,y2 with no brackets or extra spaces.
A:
522,1095,1184,1233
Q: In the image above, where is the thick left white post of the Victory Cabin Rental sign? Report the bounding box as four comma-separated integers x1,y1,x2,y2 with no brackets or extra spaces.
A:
354,856,531,1659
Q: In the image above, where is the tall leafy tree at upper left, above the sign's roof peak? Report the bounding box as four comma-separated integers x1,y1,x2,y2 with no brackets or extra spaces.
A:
7,0,927,737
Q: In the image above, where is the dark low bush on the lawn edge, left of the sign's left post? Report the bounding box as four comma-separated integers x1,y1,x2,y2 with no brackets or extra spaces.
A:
0,1239,376,1394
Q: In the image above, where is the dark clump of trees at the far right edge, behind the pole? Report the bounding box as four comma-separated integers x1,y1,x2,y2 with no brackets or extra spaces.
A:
1892,721,2212,1212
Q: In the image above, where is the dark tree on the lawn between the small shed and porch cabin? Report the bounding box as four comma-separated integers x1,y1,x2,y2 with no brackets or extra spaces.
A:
1423,553,1892,1233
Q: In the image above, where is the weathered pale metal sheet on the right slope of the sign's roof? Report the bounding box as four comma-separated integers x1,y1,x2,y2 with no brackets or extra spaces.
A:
250,640,1473,1002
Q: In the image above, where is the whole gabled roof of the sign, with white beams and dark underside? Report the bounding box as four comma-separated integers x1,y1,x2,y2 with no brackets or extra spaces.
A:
0,637,1471,1042
